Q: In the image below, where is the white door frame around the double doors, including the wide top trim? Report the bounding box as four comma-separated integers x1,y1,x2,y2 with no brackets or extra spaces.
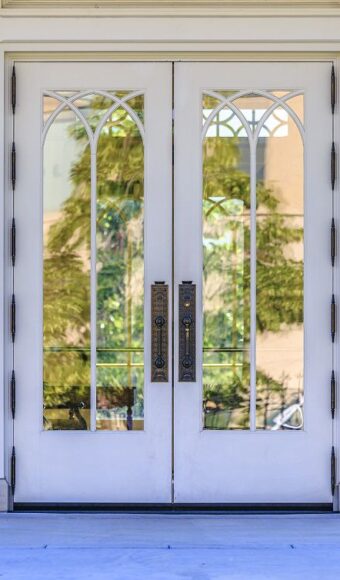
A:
0,8,340,511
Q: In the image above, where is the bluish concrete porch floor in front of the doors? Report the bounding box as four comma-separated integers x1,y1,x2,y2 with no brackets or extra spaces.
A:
0,513,340,580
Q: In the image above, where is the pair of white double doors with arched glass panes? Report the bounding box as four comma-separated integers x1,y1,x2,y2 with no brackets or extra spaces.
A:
7,62,332,504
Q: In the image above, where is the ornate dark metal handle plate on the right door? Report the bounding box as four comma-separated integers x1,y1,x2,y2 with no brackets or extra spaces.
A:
178,282,196,383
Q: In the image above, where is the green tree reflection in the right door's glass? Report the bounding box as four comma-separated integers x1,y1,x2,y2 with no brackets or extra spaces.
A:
203,137,303,429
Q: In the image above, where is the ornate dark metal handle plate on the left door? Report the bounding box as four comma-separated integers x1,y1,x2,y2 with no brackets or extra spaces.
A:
151,282,169,383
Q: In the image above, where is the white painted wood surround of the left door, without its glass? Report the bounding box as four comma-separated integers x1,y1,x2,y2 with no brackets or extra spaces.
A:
15,63,171,502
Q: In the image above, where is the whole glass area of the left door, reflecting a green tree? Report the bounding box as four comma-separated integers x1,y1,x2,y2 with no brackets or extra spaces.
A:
43,91,144,430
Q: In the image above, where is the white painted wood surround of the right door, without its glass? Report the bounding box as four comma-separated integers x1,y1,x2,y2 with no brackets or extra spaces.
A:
174,62,332,503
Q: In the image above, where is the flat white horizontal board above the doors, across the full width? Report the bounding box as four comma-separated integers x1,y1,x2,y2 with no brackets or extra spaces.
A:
0,17,340,47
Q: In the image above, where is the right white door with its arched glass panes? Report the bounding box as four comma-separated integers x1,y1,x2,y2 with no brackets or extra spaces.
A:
174,62,332,503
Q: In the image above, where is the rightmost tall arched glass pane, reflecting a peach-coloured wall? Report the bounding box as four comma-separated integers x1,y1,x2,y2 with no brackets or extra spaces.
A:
256,103,304,430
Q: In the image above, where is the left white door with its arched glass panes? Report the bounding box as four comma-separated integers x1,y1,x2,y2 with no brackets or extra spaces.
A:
8,62,172,503
